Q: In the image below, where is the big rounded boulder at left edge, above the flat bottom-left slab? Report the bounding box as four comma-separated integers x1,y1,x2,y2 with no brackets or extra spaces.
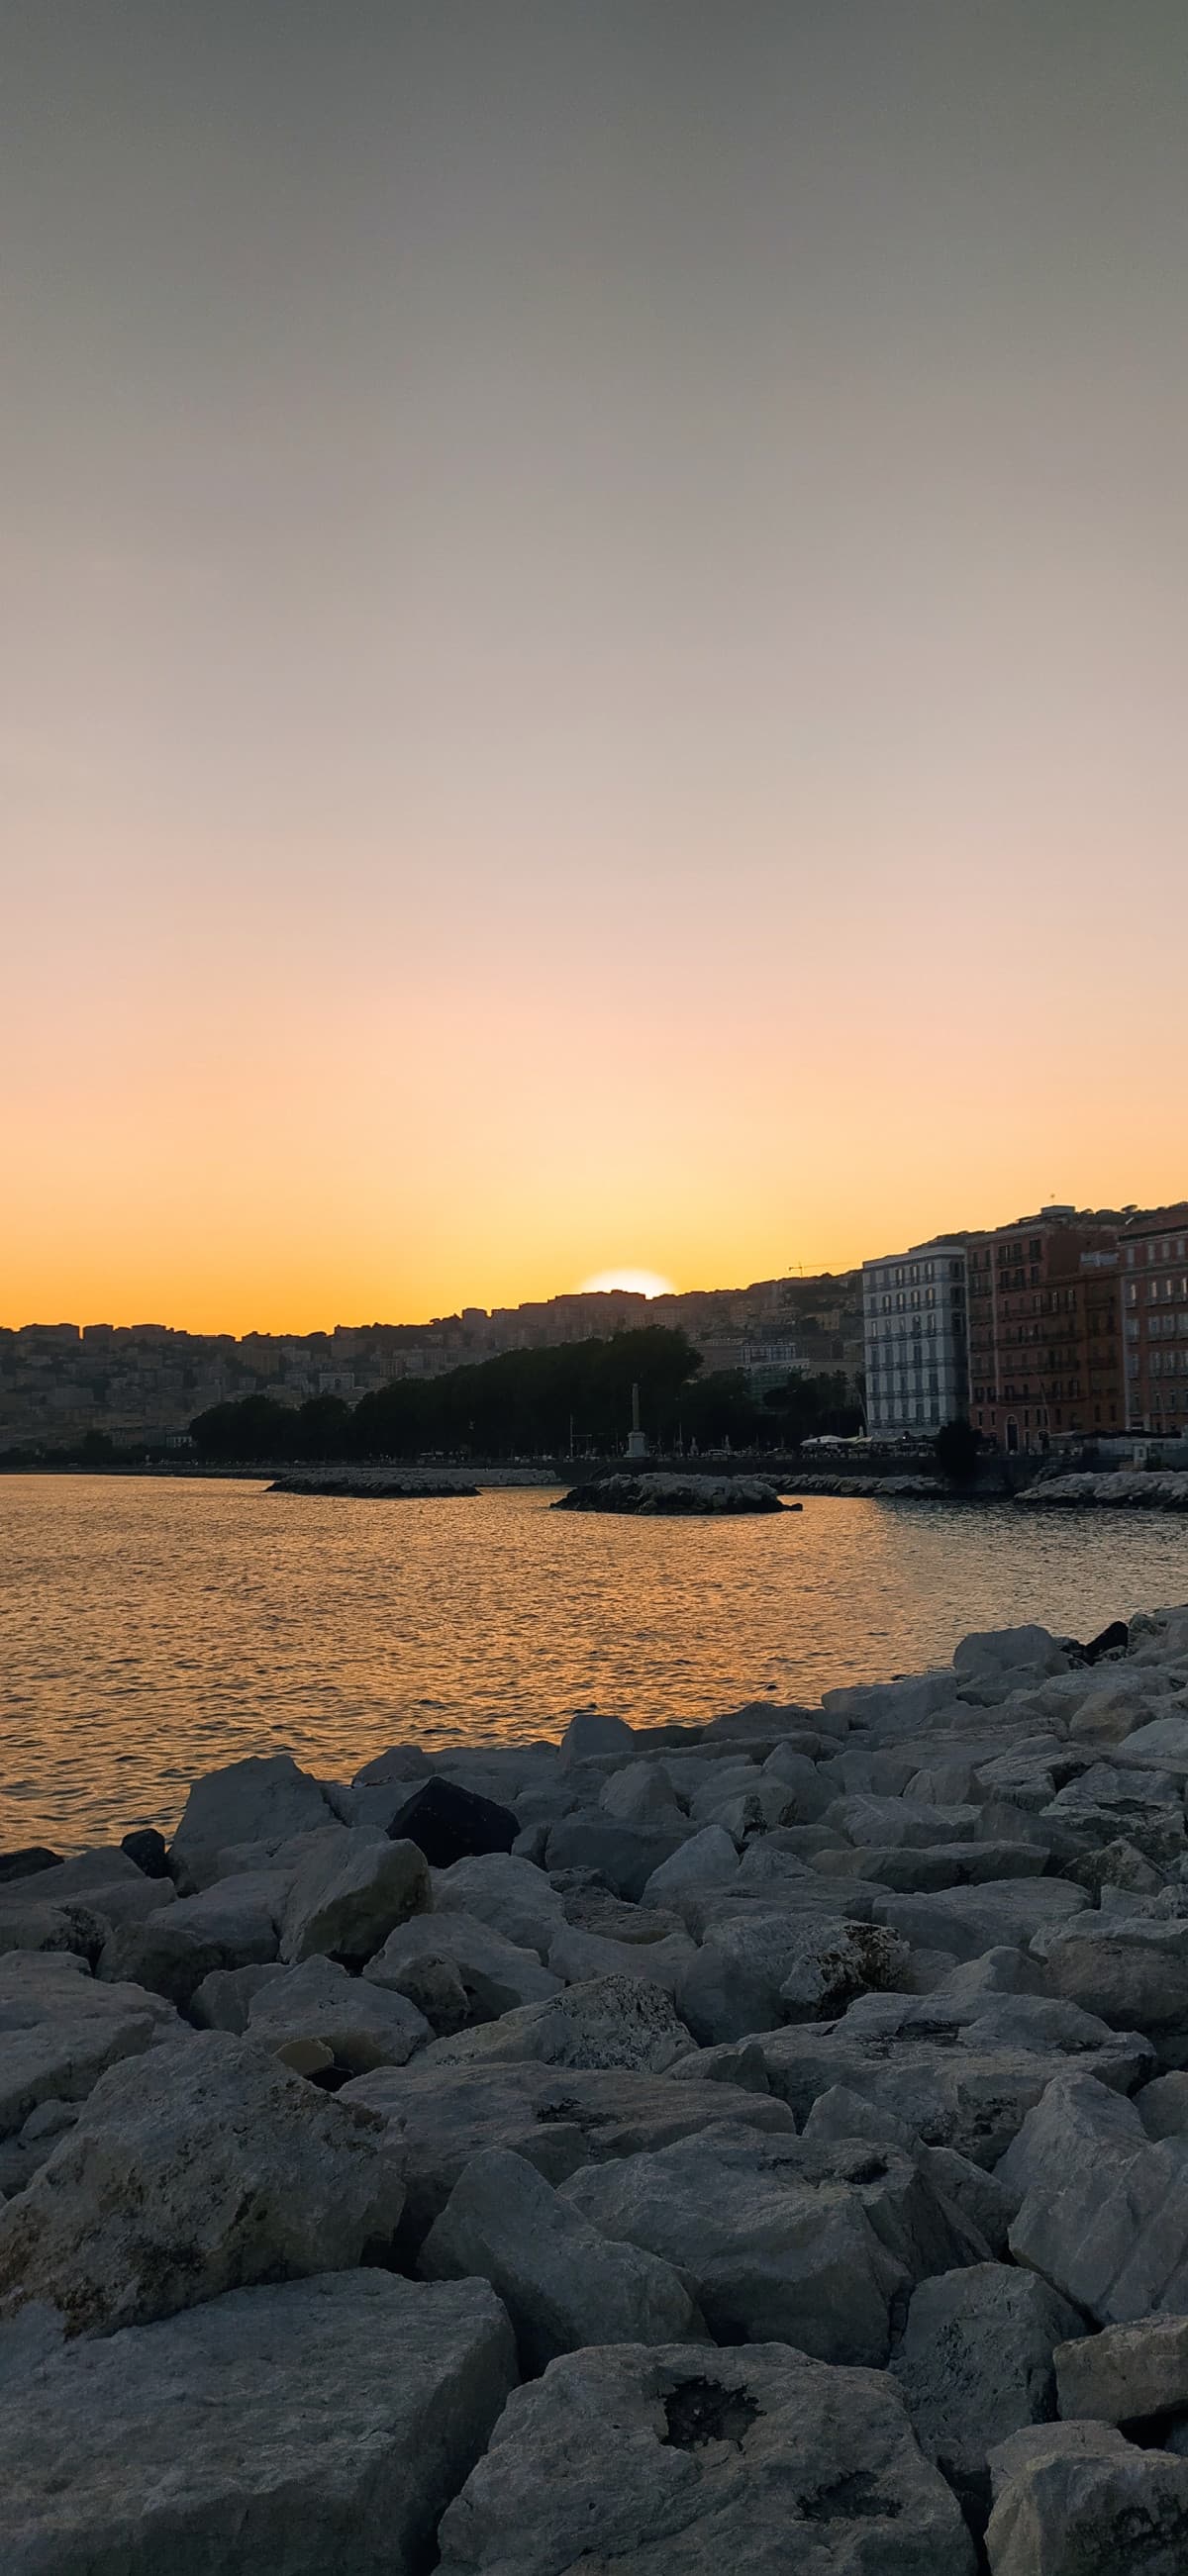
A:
0,2030,405,2334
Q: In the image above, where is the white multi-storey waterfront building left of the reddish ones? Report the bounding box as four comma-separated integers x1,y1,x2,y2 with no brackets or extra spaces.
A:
863,1242,969,1437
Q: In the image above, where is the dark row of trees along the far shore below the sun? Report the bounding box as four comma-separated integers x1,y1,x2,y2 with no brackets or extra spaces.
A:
191,1324,860,1461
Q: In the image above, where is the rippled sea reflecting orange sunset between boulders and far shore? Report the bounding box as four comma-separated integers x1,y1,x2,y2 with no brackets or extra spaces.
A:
0,1477,1188,1850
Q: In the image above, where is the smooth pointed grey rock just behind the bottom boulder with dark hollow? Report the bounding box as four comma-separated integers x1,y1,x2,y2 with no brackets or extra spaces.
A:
418,2148,706,2372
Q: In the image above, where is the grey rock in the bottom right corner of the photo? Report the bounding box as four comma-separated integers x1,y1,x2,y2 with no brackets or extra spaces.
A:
987,2424,1188,2576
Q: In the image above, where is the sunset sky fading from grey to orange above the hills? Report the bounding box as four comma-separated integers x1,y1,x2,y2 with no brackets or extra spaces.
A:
0,0,1188,1332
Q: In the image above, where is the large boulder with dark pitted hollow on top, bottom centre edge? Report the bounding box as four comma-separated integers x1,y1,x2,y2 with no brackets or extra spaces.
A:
435,2344,974,2576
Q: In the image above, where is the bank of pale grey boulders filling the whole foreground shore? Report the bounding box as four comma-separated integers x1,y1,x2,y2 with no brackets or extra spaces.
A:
0,1607,1188,2576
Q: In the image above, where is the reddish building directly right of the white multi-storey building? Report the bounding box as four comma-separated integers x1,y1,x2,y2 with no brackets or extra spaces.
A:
966,1208,1118,1450
